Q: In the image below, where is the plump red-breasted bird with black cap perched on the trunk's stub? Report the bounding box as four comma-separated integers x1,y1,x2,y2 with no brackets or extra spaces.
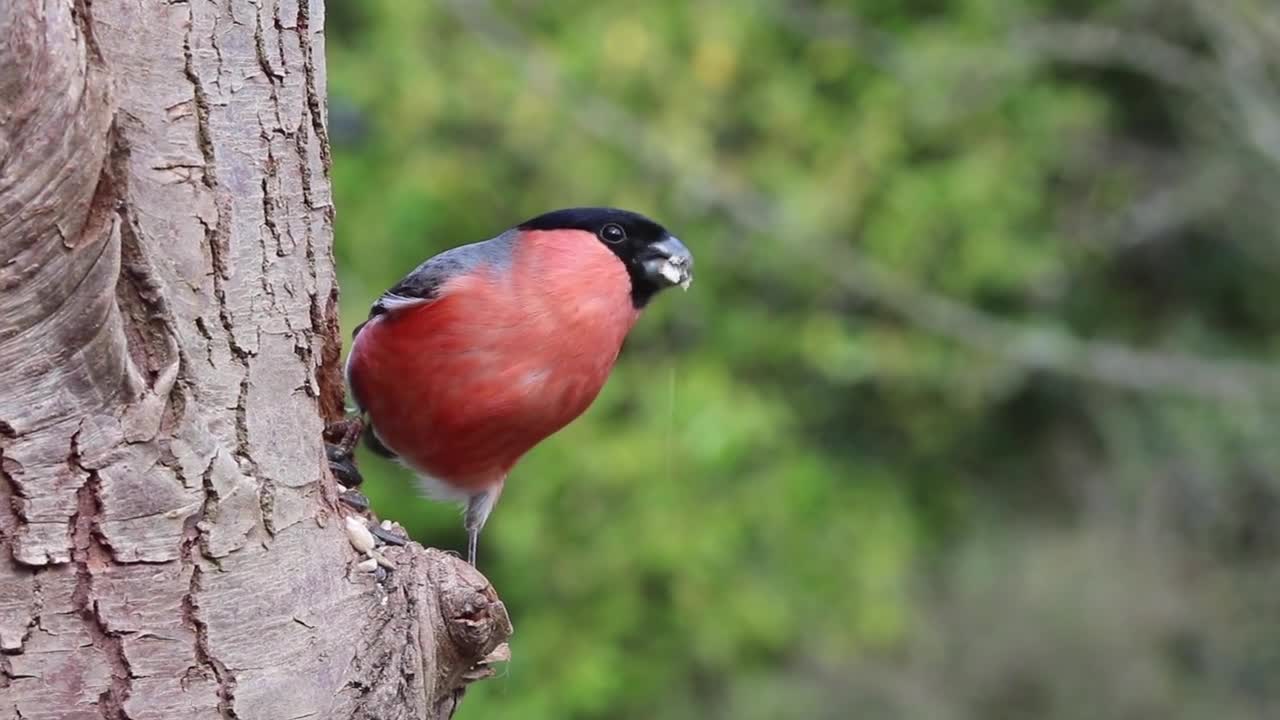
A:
347,208,694,564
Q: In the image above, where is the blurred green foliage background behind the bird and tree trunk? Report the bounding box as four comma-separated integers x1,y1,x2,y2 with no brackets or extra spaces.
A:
326,0,1280,720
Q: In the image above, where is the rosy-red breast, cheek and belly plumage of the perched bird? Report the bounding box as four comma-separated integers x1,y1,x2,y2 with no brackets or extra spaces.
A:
348,231,639,493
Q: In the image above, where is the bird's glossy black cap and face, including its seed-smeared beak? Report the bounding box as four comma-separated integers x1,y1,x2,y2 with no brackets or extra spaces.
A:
517,208,694,307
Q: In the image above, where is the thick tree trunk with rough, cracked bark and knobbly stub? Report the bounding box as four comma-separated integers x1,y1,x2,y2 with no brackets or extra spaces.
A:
0,0,509,720
